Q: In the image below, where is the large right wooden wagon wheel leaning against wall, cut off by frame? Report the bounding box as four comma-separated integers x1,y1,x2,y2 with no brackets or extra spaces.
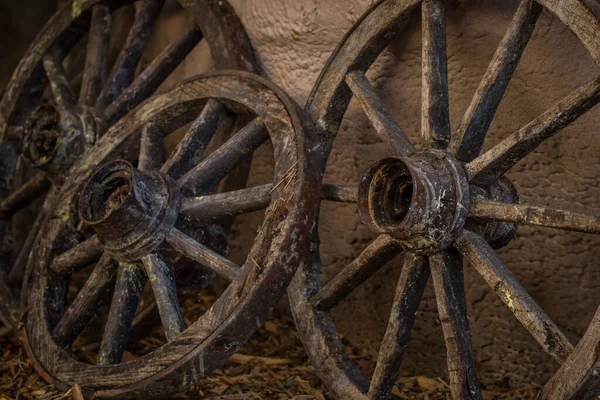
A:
289,0,600,399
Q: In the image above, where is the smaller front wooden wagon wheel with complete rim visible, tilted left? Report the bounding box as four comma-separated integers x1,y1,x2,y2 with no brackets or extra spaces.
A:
24,72,318,398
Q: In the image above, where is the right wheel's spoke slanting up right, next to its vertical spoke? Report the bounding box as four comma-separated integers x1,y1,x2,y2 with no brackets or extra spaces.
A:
450,0,542,161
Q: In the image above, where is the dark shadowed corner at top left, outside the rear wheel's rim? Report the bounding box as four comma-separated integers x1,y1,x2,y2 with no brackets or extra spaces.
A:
0,0,60,91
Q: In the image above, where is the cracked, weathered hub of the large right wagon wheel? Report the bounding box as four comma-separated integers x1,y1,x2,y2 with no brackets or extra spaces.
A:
358,149,518,254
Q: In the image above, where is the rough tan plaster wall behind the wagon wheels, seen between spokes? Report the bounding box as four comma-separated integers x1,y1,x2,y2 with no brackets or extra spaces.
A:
11,0,600,385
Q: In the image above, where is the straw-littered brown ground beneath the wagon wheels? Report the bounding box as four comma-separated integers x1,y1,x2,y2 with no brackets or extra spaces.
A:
0,299,535,400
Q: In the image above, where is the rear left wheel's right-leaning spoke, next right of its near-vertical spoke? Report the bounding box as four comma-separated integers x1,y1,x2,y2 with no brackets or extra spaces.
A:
96,0,165,110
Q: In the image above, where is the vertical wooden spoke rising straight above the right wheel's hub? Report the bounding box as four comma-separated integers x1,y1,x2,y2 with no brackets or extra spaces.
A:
421,0,450,149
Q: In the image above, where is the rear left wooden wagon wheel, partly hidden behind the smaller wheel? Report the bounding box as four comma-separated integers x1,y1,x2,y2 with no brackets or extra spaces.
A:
0,0,254,325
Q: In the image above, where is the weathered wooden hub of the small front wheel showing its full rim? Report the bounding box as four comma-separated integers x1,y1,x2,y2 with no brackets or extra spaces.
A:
79,160,181,262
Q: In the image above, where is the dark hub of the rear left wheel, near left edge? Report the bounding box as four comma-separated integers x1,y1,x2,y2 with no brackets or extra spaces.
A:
22,104,101,183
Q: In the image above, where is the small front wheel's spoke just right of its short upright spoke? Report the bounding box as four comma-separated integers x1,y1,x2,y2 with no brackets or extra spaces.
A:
162,99,227,179
